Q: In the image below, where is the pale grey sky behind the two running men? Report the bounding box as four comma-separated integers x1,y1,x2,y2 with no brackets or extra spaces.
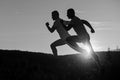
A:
0,0,120,55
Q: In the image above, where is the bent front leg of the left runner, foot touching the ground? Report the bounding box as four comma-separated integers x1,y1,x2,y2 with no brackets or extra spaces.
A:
50,39,66,56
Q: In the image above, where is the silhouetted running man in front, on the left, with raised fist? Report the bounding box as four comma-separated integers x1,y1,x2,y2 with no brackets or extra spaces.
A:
46,10,70,56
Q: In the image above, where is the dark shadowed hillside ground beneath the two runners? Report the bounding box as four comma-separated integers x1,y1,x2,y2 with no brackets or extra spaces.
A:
0,50,120,80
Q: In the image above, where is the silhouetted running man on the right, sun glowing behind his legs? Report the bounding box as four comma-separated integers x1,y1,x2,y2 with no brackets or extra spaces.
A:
65,8,101,66
